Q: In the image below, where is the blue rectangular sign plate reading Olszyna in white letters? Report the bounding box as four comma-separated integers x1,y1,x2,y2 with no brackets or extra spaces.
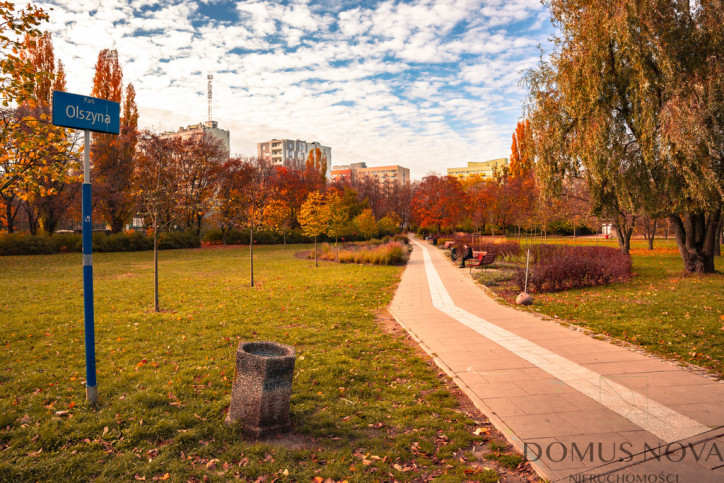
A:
53,91,121,134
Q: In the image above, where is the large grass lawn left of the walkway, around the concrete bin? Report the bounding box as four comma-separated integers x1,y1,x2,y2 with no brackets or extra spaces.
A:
0,247,512,482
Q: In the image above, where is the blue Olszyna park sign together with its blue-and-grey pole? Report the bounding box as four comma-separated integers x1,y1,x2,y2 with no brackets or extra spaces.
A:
53,91,121,404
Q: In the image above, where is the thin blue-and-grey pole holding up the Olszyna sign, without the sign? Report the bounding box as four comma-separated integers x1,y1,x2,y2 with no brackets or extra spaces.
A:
83,129,98,404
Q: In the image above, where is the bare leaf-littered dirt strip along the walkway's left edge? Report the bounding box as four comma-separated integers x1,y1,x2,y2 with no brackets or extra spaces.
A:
376,311,541,482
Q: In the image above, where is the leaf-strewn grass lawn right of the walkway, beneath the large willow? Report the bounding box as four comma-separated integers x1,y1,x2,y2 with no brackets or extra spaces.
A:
480,238,724,376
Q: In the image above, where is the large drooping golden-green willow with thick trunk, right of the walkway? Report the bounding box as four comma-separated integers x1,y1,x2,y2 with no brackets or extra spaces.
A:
526,0,724,272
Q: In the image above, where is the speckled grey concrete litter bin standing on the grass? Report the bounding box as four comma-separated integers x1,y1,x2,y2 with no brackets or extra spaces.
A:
226,341,296,438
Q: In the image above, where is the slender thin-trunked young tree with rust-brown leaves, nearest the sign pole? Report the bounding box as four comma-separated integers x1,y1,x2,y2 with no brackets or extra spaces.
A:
134,131,181,312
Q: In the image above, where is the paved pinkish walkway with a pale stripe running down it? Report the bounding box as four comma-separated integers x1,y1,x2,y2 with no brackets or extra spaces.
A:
390,239,724,482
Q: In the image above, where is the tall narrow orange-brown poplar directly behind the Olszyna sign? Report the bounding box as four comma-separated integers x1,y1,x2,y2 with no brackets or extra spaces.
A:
91,49,138,233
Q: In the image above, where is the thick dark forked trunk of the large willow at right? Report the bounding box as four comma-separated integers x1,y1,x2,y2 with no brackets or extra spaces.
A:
669,210,722,273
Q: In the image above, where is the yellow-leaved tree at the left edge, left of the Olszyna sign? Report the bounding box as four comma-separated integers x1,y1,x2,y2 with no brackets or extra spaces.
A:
0,6,77,232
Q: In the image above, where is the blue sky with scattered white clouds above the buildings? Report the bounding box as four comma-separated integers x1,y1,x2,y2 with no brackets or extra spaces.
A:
38,0,553,179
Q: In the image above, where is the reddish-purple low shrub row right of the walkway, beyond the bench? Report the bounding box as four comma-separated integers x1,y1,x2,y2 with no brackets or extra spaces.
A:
516,245,631,292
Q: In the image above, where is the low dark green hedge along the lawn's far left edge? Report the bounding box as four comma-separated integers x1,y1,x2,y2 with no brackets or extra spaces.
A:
0,231,200,256
